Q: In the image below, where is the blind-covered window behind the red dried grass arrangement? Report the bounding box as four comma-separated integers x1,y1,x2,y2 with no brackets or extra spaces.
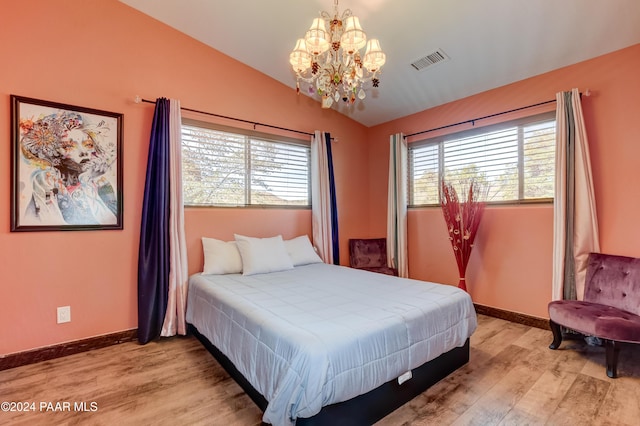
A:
409,112,556,206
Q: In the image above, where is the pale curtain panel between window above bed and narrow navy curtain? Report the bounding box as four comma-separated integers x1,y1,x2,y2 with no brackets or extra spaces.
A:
311,131,333,264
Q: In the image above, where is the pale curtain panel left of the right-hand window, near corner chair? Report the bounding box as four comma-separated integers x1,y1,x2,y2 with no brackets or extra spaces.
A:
387,133,409,278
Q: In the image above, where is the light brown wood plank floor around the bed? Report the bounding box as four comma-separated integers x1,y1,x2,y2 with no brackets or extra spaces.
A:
0,315,640,426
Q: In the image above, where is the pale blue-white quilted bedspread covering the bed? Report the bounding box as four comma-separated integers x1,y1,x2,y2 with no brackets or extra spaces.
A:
187,264,477,425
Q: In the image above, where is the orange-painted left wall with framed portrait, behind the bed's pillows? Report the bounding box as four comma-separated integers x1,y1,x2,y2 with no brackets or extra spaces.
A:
0,0,368,355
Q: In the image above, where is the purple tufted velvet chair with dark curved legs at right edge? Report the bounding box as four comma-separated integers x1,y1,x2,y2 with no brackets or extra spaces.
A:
549,253,640,378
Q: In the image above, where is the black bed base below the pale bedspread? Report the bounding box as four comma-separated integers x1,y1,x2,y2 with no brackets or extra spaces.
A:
189,324,469,426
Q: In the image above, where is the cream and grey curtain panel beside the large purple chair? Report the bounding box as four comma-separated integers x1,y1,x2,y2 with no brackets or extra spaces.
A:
552,89,600,300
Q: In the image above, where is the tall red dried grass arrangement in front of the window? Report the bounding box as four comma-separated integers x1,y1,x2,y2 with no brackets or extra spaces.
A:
440,179,486,291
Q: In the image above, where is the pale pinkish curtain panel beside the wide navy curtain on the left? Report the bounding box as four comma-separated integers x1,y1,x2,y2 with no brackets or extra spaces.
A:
161,99,188,336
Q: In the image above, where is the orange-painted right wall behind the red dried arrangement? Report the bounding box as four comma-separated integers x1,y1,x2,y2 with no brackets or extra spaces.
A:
369,45,640,317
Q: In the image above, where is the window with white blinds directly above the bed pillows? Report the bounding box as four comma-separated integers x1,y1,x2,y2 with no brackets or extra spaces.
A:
182,120,311,207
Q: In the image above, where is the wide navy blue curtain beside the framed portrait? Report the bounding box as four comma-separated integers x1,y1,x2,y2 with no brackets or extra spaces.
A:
138,98,170,344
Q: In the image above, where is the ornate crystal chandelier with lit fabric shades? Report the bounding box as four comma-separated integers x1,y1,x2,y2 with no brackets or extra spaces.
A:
289,0,386,108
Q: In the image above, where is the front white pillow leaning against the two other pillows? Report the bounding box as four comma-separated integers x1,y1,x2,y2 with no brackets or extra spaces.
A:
235,234,293,275
